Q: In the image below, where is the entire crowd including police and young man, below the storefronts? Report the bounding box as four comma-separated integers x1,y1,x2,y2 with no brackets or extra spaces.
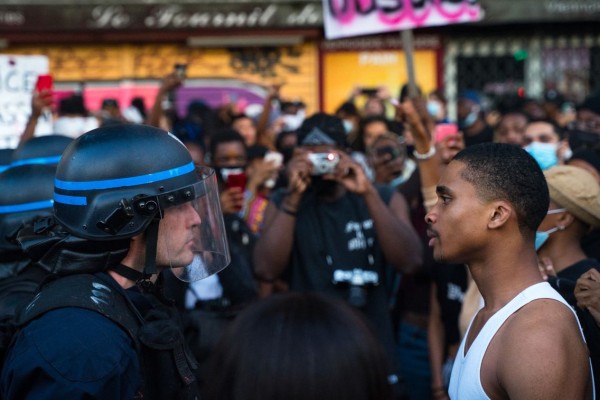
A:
0,69,600,400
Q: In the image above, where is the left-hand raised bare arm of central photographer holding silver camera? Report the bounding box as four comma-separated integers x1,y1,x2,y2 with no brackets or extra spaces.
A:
254,149,311,281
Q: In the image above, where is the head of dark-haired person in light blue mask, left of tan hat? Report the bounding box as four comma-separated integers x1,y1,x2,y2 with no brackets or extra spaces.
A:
524,119,572,170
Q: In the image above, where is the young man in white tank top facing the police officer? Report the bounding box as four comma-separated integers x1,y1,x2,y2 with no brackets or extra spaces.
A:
425,143,592,399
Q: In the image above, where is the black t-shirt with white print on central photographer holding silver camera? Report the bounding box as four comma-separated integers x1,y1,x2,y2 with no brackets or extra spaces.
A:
272,187,402,354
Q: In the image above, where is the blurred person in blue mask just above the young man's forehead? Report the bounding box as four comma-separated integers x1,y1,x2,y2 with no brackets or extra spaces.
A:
456,90,494,147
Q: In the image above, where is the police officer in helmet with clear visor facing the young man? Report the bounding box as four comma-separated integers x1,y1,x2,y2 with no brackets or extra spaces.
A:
0,125,229,400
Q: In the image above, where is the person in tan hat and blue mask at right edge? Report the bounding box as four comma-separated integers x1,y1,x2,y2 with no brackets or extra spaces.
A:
535,165,600,383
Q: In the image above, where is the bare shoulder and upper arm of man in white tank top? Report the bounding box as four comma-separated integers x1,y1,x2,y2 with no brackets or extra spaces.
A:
496,299,592,400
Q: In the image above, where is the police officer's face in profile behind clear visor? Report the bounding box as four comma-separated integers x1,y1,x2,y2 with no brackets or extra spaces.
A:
156,202,201,268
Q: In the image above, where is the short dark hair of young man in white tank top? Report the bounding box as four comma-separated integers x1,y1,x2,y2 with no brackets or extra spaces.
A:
454,143,550,236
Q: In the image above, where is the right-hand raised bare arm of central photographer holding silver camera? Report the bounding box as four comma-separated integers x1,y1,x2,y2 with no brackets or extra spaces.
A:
323,153,422,273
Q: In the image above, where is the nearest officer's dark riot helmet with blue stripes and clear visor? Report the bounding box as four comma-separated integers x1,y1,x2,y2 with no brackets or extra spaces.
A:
54,124,229,282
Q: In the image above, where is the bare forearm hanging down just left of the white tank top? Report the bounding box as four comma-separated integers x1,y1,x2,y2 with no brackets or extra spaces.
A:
427,282,448,400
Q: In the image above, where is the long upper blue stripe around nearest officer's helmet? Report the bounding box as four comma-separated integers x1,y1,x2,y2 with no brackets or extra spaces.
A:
54,162,196,190
